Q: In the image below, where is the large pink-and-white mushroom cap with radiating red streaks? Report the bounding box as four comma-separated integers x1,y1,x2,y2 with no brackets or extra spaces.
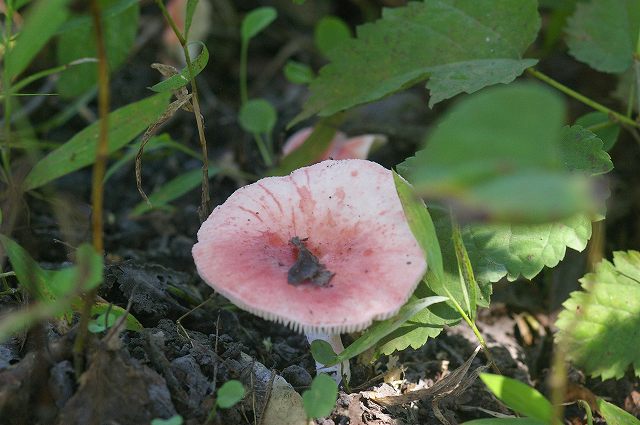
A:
193,159,427,333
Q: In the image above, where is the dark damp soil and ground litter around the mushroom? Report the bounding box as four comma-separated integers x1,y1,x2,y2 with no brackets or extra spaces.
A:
0,0,640,425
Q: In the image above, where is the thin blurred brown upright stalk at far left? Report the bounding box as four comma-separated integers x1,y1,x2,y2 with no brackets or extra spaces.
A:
73,0,110,378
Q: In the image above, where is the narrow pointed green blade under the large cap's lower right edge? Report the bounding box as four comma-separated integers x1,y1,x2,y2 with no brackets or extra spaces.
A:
316,296,448,366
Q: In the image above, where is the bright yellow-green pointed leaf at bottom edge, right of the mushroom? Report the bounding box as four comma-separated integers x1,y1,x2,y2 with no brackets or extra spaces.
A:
480,373,553,424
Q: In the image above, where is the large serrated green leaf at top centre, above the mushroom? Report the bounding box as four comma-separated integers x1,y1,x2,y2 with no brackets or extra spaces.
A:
294,0,540,122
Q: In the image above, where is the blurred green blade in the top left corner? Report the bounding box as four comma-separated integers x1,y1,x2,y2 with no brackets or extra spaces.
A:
4,0,69,79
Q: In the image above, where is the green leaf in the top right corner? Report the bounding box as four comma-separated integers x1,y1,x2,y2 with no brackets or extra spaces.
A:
567,0,640,73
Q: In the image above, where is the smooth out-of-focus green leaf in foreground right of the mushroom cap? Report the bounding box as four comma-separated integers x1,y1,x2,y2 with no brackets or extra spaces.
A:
398,84,595,223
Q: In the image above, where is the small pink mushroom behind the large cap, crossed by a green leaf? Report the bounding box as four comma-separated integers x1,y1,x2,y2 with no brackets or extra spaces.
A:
282,127,387,161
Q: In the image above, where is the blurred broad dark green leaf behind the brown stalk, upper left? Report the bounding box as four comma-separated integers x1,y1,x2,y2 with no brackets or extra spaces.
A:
57,0,140,97
